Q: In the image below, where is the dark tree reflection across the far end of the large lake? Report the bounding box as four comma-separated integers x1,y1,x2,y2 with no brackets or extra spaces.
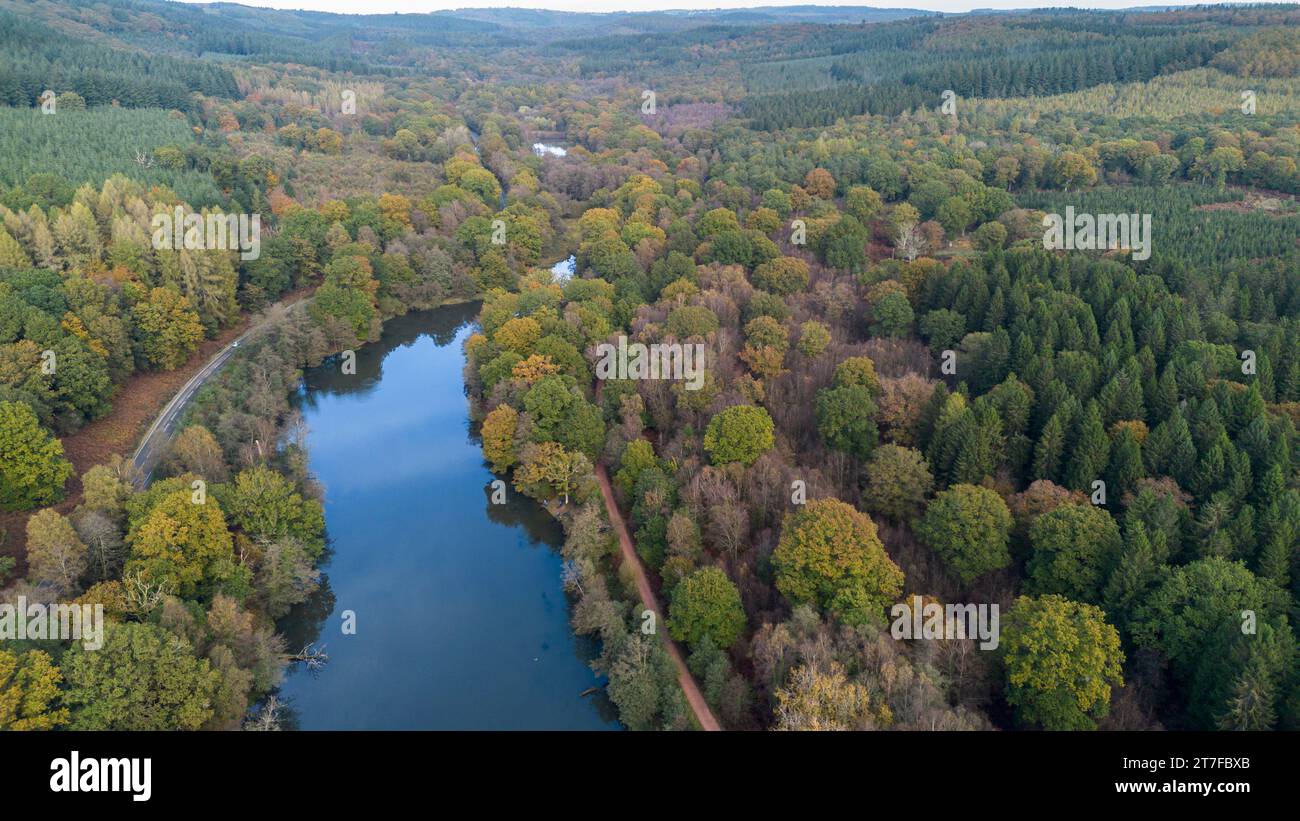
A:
299,303,478,408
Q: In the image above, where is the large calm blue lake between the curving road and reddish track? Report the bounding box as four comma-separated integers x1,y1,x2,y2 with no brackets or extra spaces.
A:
280,303,620,730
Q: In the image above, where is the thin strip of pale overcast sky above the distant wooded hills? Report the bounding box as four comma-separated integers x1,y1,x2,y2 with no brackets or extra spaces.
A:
178,0,1253,14
